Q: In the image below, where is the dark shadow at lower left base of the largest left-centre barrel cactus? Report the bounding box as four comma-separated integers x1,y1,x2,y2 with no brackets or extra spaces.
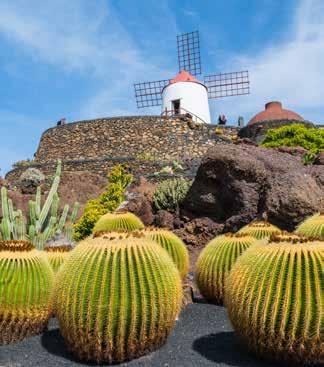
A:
41,329,97,366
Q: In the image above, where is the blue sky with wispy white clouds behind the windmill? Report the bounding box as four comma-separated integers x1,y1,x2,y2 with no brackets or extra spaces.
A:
0,0,324,174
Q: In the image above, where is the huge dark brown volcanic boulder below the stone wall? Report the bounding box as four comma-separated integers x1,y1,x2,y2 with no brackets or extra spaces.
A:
182,144,324,231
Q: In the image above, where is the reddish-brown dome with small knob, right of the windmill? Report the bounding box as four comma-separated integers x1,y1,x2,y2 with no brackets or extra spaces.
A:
248,102,305,125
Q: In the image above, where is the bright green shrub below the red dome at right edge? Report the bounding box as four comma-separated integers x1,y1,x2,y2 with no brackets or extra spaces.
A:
261,124,324,154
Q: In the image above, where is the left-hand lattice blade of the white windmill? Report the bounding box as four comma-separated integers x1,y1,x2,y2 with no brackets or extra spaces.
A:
134,79,170,108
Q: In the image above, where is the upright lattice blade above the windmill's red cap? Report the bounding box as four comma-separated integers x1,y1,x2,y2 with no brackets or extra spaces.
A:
177,31,201,75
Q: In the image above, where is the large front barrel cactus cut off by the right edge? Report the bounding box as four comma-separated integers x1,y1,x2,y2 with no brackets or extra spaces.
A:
225,237,324,366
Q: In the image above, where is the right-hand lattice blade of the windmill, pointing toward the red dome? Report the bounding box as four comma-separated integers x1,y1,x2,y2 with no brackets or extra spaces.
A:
204,71,250,98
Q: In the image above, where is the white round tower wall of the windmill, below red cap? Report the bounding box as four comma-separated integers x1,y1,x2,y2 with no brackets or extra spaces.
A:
162,82,210,124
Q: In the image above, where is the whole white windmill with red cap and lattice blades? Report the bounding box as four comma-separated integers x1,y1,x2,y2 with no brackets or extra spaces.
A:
134,31,250,123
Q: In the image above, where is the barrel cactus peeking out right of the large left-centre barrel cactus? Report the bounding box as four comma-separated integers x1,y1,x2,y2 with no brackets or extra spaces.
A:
143,228,189,278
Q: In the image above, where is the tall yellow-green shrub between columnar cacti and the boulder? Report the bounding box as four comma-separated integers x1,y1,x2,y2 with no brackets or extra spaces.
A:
74,164,133,241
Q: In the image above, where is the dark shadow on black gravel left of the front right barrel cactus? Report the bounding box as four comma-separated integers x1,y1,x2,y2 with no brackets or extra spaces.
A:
193,331,273,367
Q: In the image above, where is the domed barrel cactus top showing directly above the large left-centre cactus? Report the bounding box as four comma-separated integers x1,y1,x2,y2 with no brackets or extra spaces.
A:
93,212,144,235
